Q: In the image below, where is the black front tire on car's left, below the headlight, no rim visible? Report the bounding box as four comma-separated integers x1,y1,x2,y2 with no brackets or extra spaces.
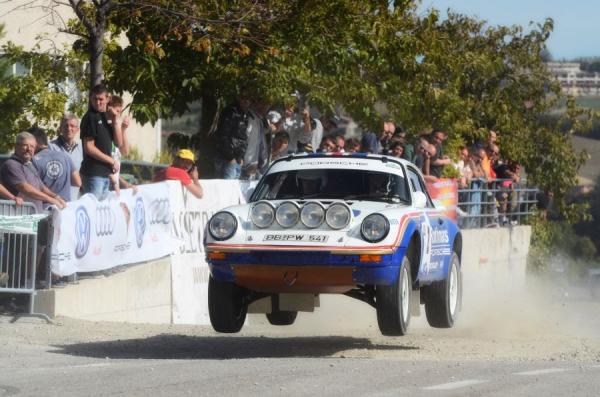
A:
208,275,248,334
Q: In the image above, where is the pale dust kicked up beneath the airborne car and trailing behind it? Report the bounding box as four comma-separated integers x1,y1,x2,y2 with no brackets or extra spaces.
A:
248,258,600,339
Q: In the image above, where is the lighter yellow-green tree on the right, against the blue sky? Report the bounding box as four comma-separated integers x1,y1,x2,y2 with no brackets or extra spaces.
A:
385,13,589,206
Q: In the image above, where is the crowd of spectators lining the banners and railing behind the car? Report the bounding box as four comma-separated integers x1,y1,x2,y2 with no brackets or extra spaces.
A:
0,85,536,223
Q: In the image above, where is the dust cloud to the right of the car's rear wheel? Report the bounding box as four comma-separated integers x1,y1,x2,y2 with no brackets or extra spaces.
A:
457,258,600,338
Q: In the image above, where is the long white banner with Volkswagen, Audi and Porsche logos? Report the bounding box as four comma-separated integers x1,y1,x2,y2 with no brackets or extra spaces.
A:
51,182,173,276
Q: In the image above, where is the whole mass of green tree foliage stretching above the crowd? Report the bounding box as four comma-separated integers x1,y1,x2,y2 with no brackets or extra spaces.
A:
0,0,589,213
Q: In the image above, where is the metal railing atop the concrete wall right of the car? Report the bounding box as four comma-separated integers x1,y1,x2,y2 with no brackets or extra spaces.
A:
457,179,538,229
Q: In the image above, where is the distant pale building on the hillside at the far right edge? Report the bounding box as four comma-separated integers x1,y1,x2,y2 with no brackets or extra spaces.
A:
546,62,600,96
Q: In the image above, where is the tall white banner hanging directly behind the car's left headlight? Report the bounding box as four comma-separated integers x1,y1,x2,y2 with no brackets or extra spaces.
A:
170,179,250,324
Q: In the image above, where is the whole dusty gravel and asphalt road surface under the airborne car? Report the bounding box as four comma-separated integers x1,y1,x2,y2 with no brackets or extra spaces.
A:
0,284,600,396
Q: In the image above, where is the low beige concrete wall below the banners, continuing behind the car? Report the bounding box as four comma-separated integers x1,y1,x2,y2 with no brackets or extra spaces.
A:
36,226,531,326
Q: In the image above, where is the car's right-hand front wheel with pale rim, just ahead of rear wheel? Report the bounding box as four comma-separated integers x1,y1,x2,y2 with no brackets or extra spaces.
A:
375,256,412,336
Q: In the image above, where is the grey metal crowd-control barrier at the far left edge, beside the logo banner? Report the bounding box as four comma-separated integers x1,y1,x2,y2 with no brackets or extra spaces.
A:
0,200,50,321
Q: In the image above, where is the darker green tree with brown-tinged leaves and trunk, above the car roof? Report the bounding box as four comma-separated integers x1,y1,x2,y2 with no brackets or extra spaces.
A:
107,0,404,171
